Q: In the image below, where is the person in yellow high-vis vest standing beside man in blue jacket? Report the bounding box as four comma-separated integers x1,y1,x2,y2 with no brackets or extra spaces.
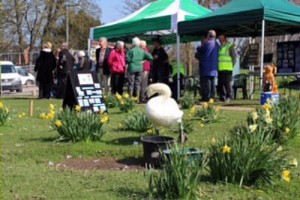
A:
218,35,236,103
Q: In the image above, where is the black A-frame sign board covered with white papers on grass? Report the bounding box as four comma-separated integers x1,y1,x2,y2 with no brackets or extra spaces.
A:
63,72,107,113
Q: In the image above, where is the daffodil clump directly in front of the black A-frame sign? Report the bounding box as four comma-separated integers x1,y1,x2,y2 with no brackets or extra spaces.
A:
52,109,109,142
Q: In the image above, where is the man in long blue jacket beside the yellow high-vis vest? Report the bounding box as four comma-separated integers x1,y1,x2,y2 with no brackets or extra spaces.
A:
196,30,220,101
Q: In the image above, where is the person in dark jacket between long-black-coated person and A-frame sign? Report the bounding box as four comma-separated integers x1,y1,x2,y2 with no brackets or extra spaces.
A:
57,42,75,98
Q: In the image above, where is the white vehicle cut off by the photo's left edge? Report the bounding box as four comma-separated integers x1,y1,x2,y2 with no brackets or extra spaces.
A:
0,61,22,92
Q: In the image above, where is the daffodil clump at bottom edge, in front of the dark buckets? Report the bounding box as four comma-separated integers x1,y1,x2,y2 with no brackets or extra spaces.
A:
148,146,202,200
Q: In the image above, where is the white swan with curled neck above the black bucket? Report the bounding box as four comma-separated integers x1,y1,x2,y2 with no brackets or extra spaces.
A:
146,83,185,142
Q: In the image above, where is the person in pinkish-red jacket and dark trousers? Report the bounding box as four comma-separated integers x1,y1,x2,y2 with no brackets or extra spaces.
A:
108,41,126,95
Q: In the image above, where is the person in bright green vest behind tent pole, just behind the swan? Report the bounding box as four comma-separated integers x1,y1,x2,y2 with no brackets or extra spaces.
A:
171,61,185,101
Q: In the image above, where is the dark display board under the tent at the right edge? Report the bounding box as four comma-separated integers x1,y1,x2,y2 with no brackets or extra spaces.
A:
277,41,300,73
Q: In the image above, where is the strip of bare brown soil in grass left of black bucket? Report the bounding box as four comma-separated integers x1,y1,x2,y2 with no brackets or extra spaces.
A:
53,157,145,171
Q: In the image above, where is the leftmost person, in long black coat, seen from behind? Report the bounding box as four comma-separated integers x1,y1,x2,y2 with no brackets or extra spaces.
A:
34,42,56,99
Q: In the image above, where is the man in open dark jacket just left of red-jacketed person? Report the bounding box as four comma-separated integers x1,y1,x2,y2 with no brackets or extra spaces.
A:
96,37,112,94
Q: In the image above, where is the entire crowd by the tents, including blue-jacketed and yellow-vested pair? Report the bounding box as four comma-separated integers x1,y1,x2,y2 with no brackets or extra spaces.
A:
34,30,236,103
